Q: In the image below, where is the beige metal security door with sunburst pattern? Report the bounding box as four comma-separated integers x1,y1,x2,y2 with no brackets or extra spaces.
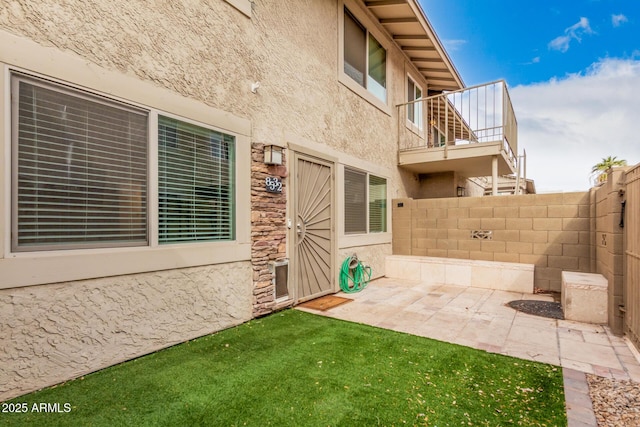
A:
293,154,334,302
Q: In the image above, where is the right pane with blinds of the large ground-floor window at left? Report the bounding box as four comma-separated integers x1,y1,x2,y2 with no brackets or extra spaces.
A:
158,116,235,244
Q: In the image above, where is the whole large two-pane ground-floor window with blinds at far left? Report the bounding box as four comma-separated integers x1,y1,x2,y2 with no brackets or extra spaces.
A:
11,73,236,252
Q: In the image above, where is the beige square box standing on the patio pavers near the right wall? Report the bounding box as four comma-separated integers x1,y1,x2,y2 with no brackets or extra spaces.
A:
561,271,608,324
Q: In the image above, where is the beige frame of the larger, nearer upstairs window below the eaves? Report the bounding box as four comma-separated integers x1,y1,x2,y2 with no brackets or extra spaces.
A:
338,0,392,116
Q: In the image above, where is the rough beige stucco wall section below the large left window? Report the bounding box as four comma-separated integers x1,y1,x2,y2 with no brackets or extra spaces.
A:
0,262,252,400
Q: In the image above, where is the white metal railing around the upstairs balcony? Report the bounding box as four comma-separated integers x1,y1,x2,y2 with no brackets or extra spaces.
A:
397,80,518,169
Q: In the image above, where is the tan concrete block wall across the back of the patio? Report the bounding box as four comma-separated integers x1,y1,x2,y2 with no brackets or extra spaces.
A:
392,192,593,291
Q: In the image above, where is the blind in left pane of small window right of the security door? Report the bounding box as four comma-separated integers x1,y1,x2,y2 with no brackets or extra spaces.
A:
344,168,367,234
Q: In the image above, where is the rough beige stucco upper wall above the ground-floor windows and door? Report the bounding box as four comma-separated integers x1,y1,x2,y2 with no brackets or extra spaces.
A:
0,0,417,197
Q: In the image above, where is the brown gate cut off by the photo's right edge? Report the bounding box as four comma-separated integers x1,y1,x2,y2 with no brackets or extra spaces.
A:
624,165,640,348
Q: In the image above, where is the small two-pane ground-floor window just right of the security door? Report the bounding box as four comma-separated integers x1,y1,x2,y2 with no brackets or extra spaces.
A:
344,168,387,234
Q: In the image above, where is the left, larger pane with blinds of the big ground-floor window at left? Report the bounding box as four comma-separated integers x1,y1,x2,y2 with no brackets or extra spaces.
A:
11,74,148,251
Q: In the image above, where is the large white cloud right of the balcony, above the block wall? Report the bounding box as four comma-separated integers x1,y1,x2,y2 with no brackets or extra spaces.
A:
510,59,640,192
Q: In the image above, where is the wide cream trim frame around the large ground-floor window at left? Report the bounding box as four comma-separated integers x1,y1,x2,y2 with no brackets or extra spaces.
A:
0,59,251,289
